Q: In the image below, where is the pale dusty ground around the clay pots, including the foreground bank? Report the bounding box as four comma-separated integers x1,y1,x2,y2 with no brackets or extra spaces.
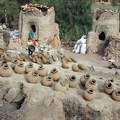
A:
0,42,120,120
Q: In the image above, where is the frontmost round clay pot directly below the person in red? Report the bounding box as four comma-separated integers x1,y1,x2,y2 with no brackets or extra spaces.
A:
26,70,39,84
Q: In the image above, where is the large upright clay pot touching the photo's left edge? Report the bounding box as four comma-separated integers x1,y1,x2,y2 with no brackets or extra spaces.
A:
0,63,12,77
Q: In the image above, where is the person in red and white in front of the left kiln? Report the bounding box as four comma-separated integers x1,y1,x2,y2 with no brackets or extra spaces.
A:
28,38,38,56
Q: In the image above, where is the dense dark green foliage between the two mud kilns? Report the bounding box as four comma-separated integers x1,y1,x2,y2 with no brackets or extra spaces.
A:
48,0,92,40
